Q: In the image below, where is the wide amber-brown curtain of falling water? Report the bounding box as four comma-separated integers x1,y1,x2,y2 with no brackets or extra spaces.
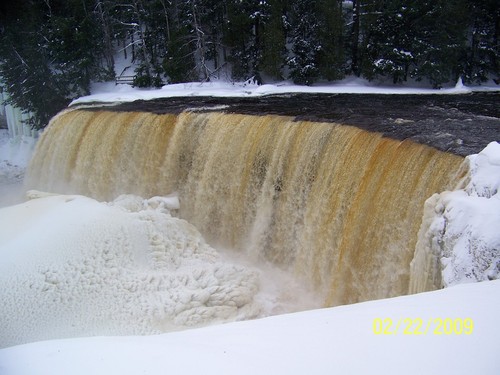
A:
26,109,463,305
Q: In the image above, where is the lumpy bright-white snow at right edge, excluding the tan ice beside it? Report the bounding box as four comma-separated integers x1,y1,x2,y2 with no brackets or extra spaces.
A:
442,142,500,287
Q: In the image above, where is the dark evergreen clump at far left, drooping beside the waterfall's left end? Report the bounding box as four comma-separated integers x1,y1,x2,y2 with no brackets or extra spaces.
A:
0,1,109,128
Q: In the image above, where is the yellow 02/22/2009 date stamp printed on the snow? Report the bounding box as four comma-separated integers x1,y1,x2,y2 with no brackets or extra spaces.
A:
372,318,474,335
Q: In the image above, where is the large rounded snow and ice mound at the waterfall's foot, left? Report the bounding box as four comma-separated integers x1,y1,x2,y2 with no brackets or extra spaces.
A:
0,191,259,347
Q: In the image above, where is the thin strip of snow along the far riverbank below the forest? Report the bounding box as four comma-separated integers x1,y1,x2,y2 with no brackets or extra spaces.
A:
75,77,500,105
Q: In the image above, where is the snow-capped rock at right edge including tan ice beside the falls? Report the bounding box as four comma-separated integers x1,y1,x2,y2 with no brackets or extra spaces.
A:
410,142,500,292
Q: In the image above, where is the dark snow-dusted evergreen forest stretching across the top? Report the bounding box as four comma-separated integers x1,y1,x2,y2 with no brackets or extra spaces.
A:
0,0,500,129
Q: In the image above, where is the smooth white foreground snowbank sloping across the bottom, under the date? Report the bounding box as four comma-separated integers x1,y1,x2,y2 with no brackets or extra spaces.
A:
0,281,500,375
